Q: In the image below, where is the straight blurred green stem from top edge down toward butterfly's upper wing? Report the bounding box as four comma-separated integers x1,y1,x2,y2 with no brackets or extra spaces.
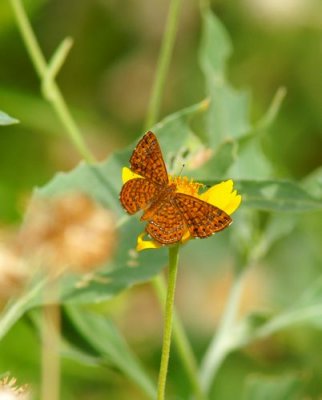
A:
145,0,182,130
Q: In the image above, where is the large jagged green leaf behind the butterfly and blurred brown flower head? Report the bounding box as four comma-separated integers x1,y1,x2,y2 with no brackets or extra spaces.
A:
0,102,209,338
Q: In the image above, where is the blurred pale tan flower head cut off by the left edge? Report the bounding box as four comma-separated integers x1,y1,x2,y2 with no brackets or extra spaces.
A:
0,244,28,304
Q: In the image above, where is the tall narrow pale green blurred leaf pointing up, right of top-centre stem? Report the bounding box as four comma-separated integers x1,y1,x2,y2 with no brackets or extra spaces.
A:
200,8,251,148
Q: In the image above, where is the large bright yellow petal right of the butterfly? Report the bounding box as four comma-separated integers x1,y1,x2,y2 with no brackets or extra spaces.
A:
200,179,241,215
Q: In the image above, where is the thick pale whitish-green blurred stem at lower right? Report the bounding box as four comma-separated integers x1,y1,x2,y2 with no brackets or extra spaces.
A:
200,272,245,393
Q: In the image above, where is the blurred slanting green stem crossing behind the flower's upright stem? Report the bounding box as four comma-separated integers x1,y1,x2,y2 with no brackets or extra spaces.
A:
153,276,205,400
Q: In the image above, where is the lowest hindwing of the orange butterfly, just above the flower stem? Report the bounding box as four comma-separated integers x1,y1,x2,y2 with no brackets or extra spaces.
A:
146,201,187,244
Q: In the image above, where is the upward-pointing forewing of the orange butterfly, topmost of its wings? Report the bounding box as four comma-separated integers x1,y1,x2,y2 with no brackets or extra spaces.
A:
130,131,169,185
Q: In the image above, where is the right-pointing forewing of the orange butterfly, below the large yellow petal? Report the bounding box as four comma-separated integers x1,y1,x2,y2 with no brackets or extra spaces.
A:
173,193,232,238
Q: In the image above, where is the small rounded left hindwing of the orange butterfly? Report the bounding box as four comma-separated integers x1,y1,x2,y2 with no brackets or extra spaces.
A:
120,178,158,214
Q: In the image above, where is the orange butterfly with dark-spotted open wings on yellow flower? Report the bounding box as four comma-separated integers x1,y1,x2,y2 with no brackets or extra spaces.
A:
120,131,232,245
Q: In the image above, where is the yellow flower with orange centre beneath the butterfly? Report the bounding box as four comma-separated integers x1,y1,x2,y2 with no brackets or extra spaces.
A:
122,167,241,251
